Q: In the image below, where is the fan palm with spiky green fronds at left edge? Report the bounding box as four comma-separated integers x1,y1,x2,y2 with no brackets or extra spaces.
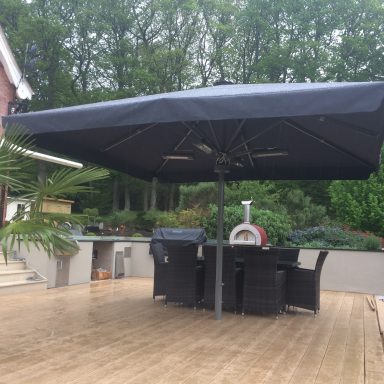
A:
0,127,109,260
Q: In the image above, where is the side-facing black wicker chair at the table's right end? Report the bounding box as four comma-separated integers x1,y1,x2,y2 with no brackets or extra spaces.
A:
287,251,328,316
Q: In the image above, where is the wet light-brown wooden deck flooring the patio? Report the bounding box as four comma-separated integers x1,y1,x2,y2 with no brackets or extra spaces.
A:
0,278,384,384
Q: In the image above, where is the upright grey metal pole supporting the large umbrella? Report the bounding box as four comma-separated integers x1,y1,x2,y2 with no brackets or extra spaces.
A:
215,169,225,320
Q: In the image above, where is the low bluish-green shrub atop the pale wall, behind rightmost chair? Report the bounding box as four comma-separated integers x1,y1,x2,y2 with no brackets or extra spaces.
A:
288,226,364,249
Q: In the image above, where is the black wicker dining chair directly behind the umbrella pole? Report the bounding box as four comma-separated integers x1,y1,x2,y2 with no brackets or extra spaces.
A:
203,245,243,313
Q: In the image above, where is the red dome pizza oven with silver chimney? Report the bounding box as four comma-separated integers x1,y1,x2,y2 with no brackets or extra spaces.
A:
229,200,268,247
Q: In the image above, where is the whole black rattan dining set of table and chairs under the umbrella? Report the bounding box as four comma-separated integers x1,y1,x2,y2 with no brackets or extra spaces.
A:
151,243,328,318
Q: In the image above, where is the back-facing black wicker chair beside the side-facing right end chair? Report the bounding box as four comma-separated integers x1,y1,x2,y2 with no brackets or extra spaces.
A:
240,246,287,318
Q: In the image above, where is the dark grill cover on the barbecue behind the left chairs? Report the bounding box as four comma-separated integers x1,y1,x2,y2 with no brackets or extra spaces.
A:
151,228,207,247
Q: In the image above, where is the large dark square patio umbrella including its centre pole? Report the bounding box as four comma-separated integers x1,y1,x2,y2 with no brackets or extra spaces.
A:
3,82,384,319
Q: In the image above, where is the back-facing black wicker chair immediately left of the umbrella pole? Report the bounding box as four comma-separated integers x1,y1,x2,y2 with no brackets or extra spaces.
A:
165,244,204,308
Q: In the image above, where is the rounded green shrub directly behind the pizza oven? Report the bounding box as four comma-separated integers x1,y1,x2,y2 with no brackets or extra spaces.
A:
202,205,291,245
